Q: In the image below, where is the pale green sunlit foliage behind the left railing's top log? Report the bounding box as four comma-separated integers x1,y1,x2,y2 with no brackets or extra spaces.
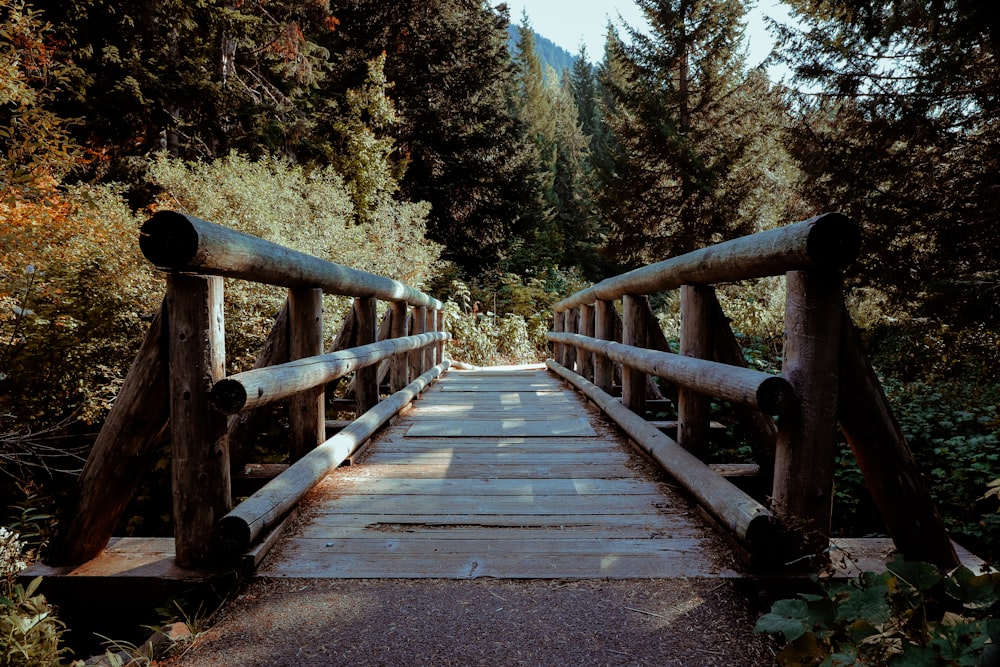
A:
149,153,440,367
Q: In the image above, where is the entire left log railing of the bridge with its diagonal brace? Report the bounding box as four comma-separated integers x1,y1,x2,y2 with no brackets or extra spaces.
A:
50,211,448,568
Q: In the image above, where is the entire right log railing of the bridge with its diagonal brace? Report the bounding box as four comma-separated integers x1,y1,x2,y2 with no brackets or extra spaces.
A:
548,213,958,568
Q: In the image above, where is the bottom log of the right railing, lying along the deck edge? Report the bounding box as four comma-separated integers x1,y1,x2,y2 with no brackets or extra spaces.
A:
545,359,781,554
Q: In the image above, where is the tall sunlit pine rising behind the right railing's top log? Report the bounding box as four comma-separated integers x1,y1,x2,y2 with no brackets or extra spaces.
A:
599,0,759,263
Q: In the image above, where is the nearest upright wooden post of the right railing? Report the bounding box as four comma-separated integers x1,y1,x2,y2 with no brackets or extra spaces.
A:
772,271,844,555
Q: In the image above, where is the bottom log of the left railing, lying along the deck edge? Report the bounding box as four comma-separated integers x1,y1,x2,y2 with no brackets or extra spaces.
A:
216,359,451,557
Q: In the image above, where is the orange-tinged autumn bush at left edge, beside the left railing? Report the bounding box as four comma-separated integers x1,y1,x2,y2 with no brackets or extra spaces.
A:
0,186,162,433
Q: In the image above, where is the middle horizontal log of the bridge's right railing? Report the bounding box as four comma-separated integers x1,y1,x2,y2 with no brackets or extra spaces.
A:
547,332,795,415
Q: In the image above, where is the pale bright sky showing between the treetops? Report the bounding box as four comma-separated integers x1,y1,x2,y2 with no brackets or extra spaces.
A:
506,0,788,73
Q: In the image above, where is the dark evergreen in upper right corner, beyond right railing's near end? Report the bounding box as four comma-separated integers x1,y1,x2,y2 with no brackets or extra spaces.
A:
778,0,1000,320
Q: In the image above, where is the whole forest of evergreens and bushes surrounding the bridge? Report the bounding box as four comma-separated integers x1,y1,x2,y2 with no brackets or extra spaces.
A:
0,0,1000,664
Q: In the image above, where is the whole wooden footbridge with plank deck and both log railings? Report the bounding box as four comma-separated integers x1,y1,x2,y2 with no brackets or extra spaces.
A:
29,212,969,612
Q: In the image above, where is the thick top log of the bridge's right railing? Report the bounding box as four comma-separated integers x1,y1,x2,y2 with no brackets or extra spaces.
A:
553,213,861,313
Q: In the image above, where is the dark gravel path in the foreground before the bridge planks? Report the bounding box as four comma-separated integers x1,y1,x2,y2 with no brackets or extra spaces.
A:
166,579,774,667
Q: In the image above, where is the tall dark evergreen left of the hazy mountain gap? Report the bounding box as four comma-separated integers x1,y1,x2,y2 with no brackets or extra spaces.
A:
322,0,542,275
